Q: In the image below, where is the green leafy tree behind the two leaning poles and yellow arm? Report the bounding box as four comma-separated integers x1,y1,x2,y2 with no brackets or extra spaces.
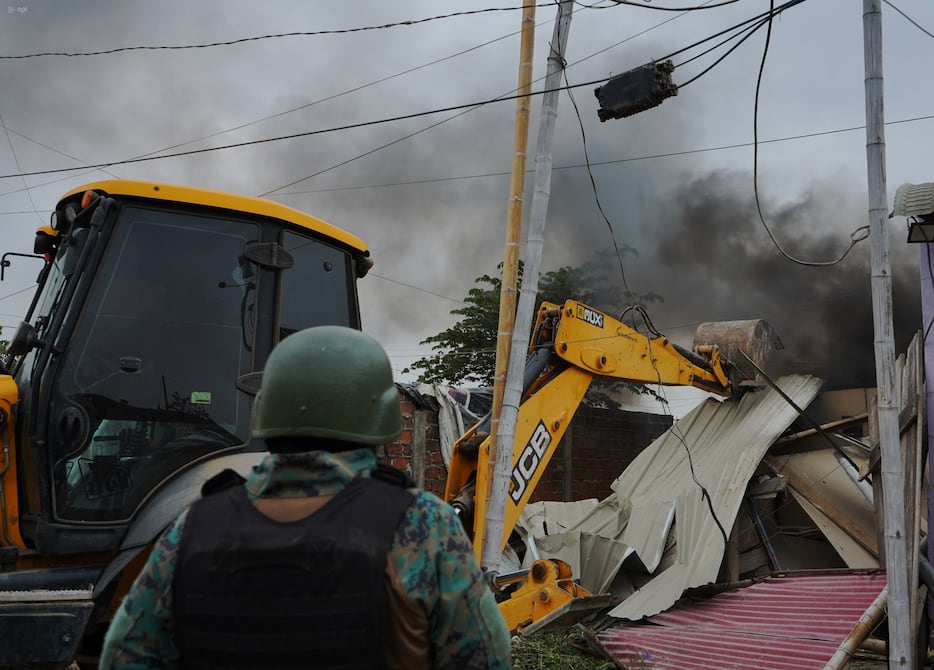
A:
405,255,661,386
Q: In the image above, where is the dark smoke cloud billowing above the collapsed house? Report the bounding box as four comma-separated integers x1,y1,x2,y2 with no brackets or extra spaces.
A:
548,171,922,390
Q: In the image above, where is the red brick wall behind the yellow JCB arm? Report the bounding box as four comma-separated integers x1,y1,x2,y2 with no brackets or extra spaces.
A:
377,394,672,501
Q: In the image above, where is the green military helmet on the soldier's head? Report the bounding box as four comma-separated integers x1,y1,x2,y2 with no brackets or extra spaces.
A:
253,326,402,445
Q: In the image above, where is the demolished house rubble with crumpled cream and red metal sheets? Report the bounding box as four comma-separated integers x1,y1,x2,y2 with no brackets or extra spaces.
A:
390,338,929,669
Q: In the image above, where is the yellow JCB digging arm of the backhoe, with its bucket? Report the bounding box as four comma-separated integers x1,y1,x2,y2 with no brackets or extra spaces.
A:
444,300,780,632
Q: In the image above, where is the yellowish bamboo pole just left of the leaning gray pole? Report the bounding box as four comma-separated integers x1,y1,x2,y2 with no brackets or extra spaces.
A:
477,0,535,570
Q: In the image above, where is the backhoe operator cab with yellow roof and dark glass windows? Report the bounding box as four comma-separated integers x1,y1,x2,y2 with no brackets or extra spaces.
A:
0,181,372,667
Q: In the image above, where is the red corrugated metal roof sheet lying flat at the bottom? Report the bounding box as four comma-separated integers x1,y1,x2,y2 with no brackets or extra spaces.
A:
598,571,885,670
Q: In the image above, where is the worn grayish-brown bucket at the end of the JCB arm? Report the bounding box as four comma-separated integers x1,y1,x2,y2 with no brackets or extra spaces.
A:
694,319,783,389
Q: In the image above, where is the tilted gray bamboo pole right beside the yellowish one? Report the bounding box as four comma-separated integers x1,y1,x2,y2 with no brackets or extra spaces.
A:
481,0,574,570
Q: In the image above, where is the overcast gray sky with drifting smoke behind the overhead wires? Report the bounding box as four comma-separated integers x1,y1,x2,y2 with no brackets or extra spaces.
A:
0,0,934,394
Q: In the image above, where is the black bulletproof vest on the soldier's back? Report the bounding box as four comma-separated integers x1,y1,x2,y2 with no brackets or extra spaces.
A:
173,470,413,670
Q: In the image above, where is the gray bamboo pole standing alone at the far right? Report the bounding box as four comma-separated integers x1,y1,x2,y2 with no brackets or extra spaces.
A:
863,0,915,668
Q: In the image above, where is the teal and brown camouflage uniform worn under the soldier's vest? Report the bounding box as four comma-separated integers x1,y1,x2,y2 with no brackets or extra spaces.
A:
100,448,511,670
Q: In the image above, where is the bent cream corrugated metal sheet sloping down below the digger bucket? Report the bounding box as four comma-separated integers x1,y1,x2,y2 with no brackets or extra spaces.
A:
520,375,821,620
